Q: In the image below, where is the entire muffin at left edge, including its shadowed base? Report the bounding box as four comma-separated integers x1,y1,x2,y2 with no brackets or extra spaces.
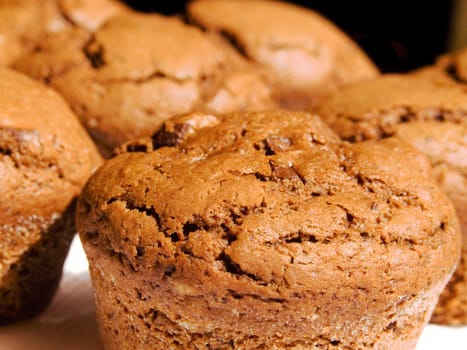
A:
0,68,101,324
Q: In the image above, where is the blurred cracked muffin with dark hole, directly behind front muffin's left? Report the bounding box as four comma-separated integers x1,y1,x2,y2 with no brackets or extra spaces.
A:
16,13,276,153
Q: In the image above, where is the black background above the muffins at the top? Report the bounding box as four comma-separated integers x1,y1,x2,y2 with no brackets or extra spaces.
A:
127,0,453,72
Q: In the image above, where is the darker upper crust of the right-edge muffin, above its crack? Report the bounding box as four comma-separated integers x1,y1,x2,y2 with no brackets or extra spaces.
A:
315,72,467,141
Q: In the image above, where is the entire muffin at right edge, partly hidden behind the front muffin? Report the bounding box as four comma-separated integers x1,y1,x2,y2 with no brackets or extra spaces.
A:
316,73,467,324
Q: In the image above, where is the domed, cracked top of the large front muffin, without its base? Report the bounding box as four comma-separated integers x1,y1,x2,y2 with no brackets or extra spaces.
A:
77,111,459,315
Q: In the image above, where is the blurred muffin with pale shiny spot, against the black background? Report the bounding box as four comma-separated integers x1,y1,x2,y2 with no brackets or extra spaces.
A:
188,0,378,109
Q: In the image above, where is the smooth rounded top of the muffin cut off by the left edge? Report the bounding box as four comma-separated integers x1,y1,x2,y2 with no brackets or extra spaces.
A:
0,69,101,223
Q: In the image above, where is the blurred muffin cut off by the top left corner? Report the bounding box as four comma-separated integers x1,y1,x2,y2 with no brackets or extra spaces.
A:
0,0,125,66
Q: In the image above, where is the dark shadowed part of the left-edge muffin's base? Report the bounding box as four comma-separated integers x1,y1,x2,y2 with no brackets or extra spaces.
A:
0,201,76,325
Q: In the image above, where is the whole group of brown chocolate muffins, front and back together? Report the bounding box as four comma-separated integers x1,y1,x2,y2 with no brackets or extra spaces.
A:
0,0,467,350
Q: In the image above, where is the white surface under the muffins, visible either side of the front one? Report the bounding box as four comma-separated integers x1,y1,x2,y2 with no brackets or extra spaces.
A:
0,239,467,350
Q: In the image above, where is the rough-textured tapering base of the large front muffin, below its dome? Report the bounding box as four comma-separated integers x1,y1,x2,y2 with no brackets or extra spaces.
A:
84,241,446,350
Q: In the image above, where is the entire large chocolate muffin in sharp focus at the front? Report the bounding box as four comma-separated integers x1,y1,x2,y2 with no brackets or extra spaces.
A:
77,111,460,349
